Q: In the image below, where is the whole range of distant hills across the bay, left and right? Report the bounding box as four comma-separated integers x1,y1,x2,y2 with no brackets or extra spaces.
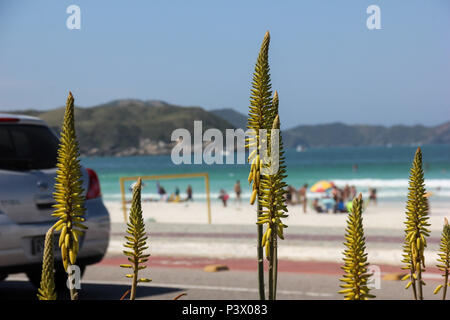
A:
6,99,450,156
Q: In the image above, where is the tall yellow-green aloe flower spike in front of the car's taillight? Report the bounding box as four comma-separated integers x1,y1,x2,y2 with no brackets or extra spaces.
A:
52,92,87,300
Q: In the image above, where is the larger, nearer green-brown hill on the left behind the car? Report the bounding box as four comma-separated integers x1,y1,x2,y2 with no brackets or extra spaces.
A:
11,99,233,156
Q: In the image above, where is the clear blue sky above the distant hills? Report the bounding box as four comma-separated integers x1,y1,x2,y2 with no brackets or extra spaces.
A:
0,0,450,127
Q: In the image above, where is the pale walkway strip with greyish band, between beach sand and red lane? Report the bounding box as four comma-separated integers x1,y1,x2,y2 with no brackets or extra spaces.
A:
108,221,439,266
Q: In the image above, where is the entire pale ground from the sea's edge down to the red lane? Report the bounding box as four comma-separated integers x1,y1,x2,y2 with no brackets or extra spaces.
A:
106,201,450,265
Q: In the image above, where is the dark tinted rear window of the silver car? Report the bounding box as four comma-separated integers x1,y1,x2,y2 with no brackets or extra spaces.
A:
0,125,58,170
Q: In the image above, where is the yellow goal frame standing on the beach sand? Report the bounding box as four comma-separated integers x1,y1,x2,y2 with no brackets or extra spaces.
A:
119,172,211,224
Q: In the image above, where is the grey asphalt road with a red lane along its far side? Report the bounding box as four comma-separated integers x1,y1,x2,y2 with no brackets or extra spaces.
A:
0,256,440,301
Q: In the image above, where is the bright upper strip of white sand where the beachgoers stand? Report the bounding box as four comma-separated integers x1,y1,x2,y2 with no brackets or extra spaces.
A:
105,201,450,230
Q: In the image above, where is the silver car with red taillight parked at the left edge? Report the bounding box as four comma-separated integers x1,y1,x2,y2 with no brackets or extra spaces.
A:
0,113,110,288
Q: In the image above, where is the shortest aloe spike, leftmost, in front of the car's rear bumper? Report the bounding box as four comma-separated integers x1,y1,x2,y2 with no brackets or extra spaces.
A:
37,227,56,300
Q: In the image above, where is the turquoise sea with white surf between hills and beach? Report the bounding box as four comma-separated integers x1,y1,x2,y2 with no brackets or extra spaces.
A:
82,145,450,201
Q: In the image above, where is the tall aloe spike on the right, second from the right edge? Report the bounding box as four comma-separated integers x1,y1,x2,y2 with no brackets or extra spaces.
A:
402,148,430,300
